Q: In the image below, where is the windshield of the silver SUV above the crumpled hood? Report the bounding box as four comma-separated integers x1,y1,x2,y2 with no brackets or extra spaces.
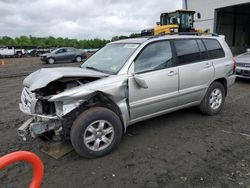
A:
81,43,139,74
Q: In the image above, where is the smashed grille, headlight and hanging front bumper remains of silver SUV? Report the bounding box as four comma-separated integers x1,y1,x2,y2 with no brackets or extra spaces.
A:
18,87,83,140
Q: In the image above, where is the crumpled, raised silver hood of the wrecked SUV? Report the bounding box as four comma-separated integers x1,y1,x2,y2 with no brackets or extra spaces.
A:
23,67,108,91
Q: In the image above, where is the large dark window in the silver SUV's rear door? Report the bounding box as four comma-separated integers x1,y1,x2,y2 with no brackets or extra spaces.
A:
174,39,201,64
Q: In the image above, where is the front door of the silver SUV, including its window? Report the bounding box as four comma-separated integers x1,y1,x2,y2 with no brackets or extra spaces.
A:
128,41,178,121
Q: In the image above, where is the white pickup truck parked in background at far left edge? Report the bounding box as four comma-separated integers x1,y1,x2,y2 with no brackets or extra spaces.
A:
0,46,27,57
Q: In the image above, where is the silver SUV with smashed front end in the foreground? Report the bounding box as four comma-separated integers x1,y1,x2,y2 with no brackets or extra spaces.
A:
18,35,235,158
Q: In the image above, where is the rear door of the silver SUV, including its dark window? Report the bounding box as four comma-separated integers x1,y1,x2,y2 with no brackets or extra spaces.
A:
174,39,214,106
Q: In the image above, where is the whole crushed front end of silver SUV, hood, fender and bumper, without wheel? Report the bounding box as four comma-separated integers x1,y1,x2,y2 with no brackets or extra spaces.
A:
18,67,129,141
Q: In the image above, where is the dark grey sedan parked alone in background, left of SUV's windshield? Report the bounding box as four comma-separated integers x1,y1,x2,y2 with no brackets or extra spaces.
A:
41,47,87,64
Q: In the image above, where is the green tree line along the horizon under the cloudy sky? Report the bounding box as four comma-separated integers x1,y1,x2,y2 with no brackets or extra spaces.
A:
0,33,142,49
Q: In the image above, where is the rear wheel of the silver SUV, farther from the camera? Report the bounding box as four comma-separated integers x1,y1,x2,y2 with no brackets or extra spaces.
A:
199,82,225,115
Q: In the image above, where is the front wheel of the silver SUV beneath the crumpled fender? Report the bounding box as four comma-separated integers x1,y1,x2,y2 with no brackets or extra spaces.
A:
70,107,123,158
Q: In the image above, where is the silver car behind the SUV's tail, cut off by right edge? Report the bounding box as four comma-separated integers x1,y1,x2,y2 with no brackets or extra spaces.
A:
235,49,250,78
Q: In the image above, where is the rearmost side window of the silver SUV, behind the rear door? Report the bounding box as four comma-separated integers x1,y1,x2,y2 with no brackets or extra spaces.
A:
203,39,225,59
